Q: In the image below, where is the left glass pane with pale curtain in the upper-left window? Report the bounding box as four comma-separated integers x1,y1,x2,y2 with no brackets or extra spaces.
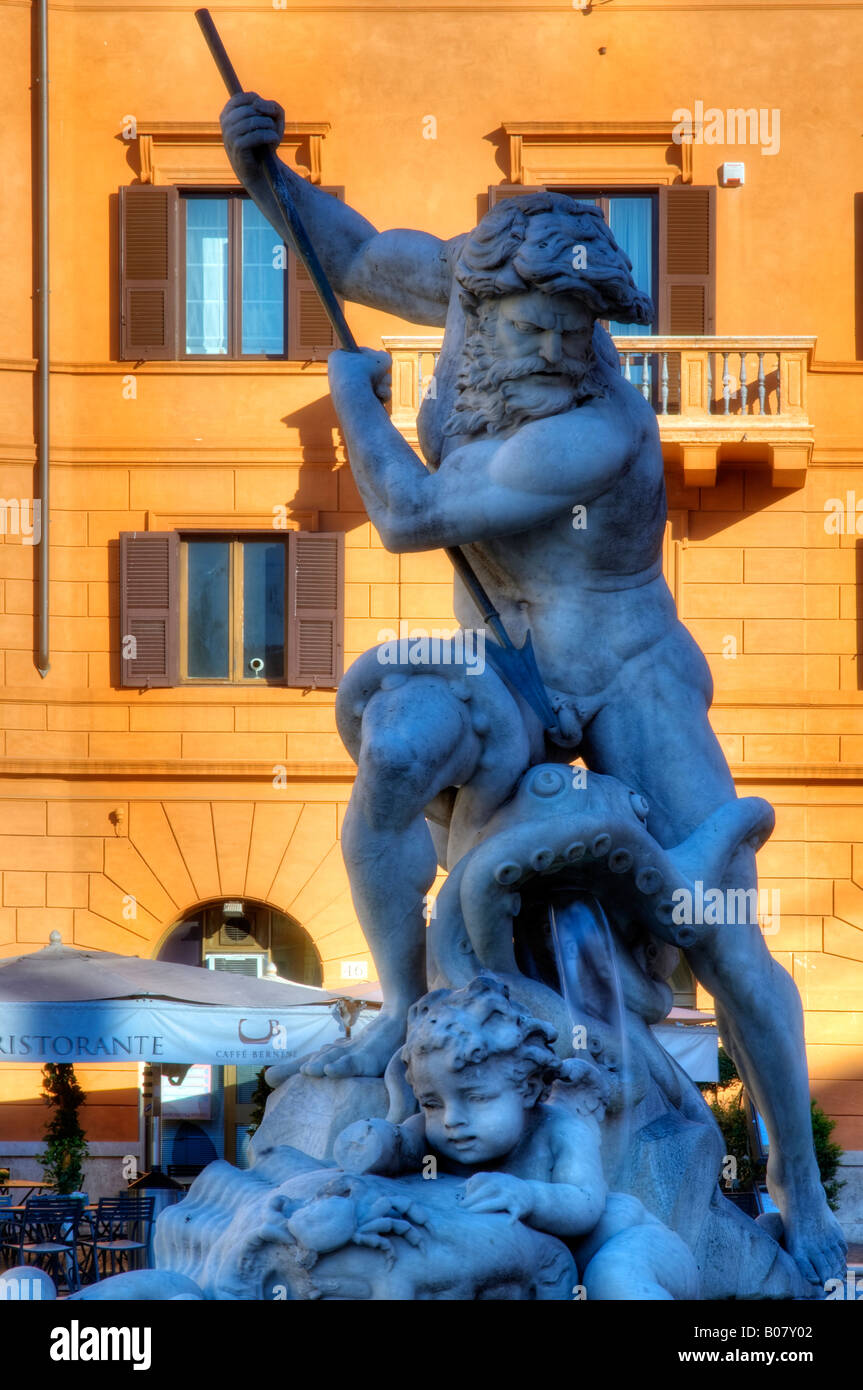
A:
186,197,228,356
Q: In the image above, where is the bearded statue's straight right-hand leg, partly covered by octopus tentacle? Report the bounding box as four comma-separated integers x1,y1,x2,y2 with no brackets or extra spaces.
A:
582,628,845,1283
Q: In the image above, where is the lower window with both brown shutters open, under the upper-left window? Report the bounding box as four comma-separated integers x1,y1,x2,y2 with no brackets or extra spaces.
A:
120,531,345,688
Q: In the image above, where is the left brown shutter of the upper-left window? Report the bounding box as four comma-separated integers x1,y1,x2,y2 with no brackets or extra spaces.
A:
120,183,179,361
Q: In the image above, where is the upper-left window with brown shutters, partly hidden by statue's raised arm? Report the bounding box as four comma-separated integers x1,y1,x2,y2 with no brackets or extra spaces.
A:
120,183,342,361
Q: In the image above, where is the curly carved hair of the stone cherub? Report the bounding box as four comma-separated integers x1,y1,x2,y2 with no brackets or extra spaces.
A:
402,974,560,1083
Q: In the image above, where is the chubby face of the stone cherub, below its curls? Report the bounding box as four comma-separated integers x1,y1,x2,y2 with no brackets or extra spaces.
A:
410,1051,538,1166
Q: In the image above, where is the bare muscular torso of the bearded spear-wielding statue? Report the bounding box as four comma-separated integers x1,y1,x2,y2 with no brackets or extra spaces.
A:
418,261,677,696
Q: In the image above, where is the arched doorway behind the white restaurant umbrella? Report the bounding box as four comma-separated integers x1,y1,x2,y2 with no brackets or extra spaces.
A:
156,898,324,1162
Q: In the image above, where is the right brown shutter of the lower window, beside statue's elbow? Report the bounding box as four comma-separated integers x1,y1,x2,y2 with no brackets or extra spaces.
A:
288,531,345,689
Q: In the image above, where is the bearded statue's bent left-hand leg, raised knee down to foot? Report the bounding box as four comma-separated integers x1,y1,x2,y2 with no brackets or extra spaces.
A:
303,676,491,1076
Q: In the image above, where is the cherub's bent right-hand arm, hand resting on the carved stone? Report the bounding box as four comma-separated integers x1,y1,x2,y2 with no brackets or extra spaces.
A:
461,1106,607,1237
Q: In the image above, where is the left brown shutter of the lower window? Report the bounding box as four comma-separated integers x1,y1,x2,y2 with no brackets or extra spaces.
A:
120,531,179,687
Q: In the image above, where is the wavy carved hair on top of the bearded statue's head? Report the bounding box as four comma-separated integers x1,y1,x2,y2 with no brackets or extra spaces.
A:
454,190,653,324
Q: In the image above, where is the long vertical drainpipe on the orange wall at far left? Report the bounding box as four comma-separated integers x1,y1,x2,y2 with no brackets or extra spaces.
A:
33,0,51,677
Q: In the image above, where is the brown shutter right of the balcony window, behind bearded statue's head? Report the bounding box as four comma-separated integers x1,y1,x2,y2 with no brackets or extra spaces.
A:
659,183,716,338
